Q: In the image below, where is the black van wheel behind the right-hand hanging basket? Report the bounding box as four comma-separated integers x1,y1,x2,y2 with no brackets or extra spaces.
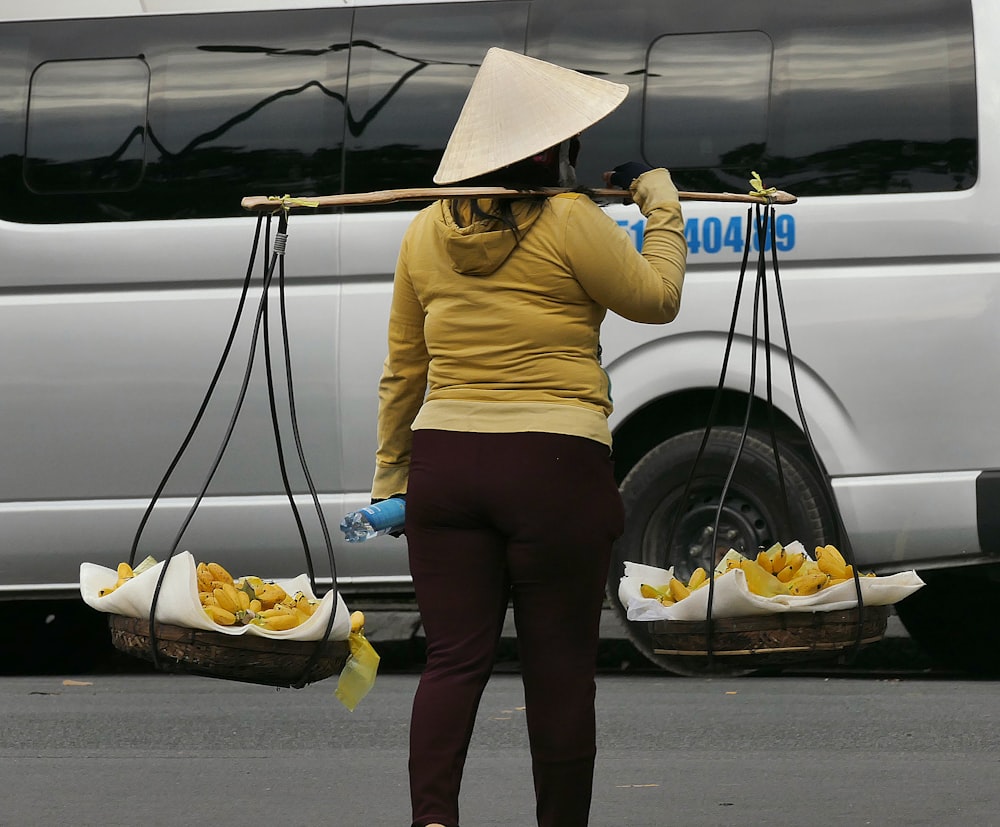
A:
608,427,835,675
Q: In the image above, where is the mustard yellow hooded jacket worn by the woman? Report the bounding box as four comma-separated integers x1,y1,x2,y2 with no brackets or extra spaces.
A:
372,169,687,498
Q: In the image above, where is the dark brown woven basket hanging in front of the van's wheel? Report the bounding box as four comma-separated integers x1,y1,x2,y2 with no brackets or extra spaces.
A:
650,606,889,668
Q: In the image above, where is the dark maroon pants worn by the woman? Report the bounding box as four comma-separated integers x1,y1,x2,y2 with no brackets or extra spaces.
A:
406,431,624,827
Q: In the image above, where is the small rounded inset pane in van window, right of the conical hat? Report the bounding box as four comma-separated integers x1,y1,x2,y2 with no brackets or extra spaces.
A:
643,32,771,171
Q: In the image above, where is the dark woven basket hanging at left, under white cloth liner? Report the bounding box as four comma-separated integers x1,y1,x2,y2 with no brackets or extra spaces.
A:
108,614,350,687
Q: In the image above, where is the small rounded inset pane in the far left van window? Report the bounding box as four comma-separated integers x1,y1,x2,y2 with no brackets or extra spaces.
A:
24,58,149,193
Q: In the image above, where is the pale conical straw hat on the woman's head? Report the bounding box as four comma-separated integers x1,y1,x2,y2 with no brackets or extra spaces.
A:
434,48,628,184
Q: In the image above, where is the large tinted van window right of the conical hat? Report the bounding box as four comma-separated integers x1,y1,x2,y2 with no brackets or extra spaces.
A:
528,0,978,196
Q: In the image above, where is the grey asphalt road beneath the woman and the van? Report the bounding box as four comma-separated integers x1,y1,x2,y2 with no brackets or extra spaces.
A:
0,672,1000,827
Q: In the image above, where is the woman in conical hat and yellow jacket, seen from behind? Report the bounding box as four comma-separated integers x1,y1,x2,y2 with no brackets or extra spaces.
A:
372,49,687,827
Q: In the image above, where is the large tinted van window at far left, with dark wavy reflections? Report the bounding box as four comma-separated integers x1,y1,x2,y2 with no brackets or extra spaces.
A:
0,10,351,223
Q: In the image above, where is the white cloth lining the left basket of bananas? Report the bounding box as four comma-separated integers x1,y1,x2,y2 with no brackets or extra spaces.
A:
80,551,351,640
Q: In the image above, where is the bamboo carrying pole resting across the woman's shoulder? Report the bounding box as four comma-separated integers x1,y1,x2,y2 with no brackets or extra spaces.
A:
241,187,798,212
